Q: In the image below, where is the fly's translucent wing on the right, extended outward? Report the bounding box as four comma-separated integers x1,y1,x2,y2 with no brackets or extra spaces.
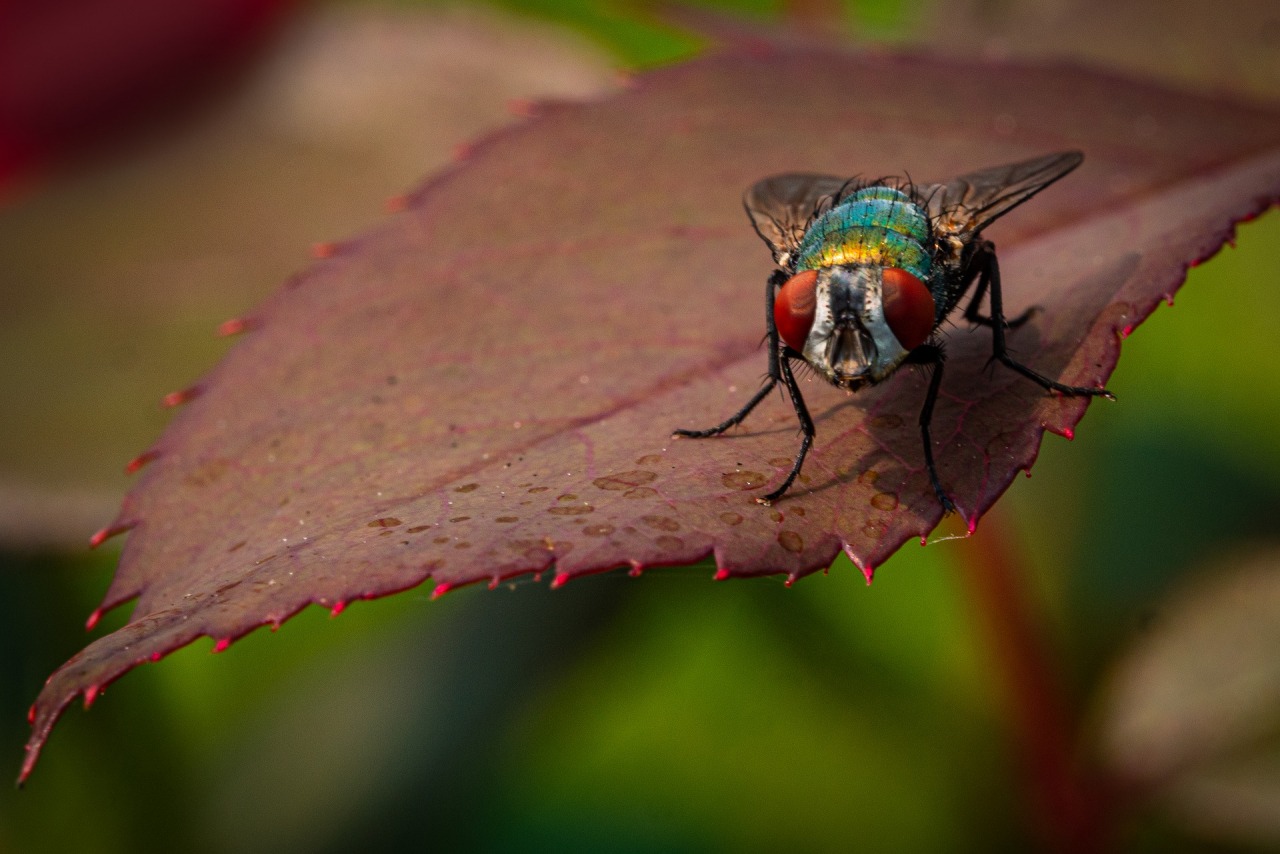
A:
915,151,1084,237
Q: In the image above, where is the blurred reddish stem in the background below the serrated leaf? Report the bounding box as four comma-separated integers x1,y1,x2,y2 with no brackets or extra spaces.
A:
957,511,1114,853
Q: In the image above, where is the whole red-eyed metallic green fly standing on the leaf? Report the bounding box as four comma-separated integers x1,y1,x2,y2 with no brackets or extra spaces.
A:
676,151,1115,512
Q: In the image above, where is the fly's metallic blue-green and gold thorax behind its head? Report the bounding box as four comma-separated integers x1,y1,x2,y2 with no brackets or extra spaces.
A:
795,187,933,282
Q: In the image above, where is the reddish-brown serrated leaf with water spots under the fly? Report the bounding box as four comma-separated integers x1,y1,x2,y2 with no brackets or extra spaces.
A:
23,46,1280,776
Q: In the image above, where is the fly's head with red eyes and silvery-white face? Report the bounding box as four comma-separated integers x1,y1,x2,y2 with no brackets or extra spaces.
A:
773,265,934,392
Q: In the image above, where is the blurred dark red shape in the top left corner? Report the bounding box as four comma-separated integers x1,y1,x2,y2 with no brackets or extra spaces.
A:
0,0,297,189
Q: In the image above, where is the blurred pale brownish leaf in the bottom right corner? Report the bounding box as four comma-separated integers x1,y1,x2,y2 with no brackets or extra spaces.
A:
1098,548,1280,846
